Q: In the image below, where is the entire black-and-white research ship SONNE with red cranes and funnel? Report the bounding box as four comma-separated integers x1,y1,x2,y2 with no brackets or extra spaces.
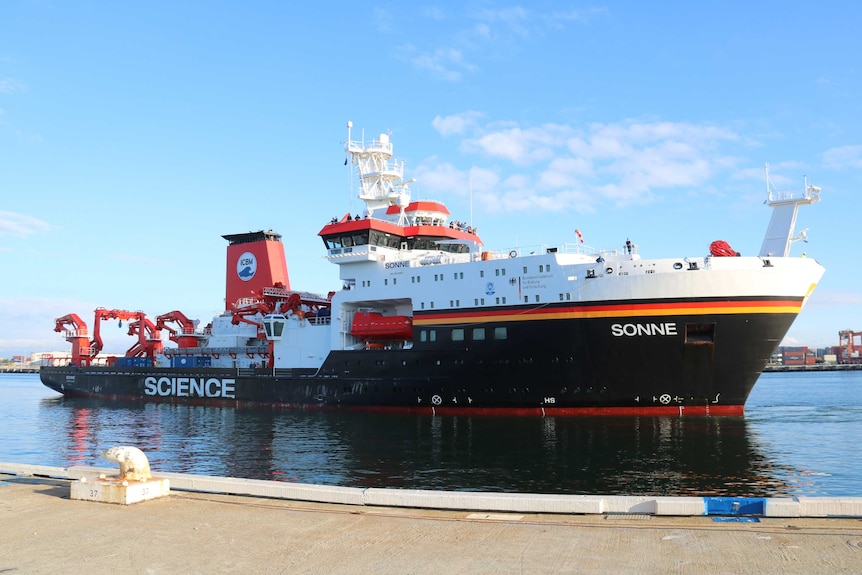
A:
41,123,824,416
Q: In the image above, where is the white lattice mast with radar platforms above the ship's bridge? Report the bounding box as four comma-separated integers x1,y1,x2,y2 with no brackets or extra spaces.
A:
344,122,415,226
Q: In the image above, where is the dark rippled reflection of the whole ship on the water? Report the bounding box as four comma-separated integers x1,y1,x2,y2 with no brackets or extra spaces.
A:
45,399,790,496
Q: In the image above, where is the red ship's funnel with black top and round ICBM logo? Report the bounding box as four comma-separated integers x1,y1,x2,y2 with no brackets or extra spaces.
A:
222,230,290,310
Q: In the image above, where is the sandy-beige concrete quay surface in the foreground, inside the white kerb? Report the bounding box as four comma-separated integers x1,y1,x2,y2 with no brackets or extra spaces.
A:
0,465,862,574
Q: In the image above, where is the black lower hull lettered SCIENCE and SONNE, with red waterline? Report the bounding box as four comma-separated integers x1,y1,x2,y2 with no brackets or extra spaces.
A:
41,313,796,416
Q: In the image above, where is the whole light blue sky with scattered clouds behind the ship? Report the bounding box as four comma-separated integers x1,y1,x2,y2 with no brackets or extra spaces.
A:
0,0,862,357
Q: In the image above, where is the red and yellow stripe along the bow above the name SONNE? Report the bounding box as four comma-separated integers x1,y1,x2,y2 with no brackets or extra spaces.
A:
414,298,802,325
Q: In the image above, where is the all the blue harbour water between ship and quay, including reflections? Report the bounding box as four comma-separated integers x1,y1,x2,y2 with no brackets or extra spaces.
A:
0,371,862,497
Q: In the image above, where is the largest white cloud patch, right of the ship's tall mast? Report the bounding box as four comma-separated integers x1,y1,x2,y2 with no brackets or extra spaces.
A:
422,117,741,212
